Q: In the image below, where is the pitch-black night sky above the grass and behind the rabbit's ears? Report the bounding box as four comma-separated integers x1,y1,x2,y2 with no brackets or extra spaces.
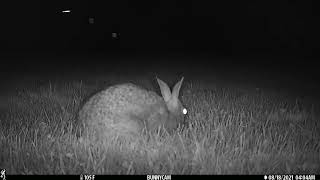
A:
0,0,320,98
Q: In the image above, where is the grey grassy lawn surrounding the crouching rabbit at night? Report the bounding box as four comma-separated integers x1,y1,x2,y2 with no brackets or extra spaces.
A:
0,76,320,174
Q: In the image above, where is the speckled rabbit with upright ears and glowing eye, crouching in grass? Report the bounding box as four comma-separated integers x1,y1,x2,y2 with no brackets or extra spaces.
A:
78,77,187,137
